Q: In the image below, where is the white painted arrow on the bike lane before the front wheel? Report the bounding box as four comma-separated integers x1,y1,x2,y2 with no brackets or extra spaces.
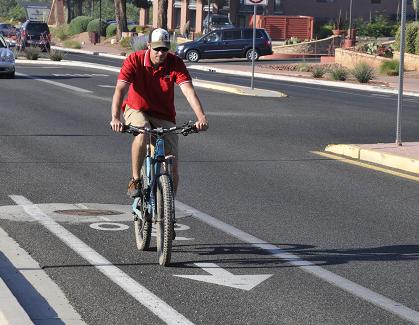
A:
174,263,273,291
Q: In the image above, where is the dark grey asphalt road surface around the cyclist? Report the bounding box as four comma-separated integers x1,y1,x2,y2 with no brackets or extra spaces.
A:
0,61,419,324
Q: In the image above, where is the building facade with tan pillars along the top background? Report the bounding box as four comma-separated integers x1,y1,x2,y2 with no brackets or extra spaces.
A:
139,0,414,33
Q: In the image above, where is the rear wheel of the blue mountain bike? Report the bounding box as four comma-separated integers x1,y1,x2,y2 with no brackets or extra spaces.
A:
134,163,151,251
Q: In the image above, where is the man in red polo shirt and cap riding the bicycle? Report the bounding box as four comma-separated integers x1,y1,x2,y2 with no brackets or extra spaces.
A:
110,28,208,197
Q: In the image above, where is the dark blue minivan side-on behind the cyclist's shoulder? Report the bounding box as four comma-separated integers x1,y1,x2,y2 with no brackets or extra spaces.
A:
176,28,272,62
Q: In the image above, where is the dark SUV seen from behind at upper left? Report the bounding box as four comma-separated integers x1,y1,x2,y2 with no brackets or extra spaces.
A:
16,20,51,51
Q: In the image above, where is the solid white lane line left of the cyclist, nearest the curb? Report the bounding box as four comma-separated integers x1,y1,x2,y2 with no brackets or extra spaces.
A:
10,195,193,325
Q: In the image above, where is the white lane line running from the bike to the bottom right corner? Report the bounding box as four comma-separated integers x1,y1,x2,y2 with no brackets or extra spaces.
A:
176,201,419,324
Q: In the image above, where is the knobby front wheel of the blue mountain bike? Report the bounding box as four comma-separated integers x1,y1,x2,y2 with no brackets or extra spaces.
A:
156,175,175,266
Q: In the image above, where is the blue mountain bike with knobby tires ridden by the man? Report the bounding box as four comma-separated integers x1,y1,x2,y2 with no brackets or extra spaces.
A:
123,121,198,266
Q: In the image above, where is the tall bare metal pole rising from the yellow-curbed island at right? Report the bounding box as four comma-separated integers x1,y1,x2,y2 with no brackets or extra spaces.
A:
396,0,406,146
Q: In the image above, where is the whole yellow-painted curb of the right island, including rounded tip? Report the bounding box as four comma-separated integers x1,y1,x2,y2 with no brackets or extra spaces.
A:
324,144,419,174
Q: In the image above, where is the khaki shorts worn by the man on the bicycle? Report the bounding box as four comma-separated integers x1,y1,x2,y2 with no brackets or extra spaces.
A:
124,106,178,157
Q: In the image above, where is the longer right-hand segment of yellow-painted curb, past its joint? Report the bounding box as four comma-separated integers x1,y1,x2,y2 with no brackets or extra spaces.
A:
359,149,419,174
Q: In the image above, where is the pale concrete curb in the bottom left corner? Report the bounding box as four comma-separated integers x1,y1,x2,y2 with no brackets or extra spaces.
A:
0,278,33,325
